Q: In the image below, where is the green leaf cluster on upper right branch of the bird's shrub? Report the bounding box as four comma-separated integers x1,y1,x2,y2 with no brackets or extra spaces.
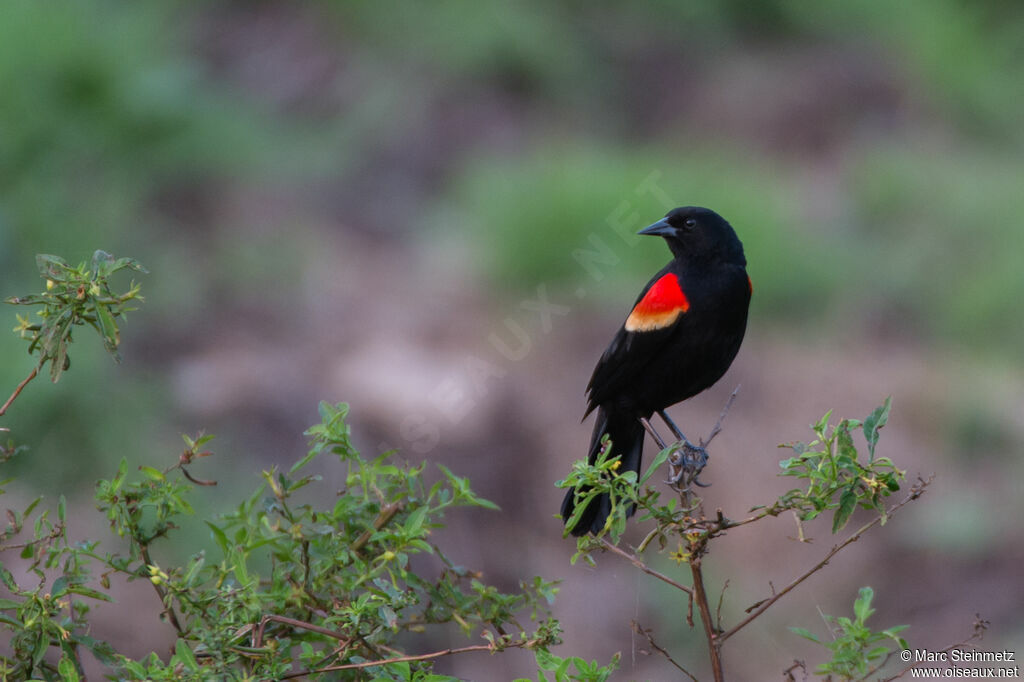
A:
776,398,904,532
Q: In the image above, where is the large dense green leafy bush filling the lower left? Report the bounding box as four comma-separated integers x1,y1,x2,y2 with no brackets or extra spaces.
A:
0,403,614,680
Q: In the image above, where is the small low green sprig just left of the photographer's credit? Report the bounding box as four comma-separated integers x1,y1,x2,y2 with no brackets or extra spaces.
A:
790,587,907,680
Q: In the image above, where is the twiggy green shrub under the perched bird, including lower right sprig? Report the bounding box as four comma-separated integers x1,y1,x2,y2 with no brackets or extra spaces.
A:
557,398,928,679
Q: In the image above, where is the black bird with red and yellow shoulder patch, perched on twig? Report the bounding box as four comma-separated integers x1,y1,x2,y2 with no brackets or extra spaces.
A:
561,206,753,536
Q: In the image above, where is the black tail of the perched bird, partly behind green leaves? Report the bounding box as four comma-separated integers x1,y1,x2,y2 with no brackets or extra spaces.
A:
562,408,644,536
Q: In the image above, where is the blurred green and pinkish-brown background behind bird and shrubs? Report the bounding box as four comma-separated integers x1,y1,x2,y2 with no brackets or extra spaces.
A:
0,0,1024,679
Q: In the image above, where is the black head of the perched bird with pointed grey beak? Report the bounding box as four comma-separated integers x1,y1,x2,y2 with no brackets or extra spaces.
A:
637,206,746,265
